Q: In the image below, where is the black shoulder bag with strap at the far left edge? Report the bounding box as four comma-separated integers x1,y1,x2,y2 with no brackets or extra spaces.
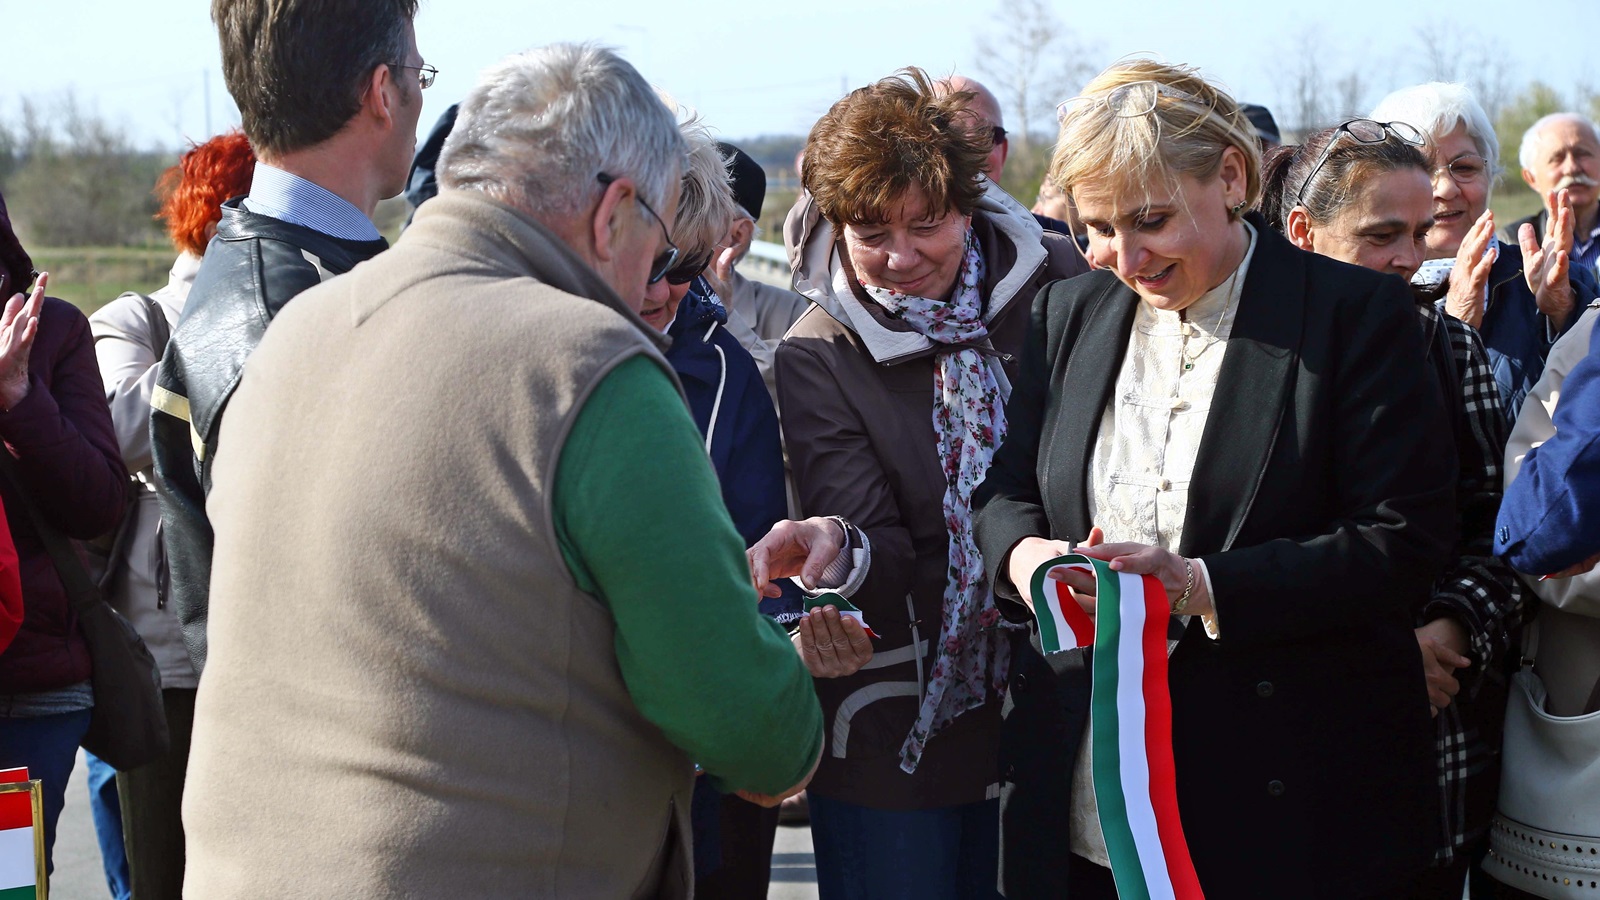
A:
0,448,171,772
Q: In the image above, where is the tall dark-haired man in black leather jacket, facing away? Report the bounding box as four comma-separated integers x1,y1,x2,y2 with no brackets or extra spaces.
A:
150,0,434,673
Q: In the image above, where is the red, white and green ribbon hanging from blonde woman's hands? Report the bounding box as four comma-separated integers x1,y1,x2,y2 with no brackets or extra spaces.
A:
1032,554,1203,900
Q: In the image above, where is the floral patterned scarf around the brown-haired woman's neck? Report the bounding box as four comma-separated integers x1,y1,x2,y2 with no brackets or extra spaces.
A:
862,229,1010,772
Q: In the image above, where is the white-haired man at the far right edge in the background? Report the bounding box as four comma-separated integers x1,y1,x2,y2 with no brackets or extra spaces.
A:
1510,112,1600,278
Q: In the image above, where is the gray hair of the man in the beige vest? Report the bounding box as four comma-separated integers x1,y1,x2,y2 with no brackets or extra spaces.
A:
438,43,685,219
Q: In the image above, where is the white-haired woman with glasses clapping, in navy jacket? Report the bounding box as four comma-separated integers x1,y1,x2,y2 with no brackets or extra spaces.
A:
1371,82,1600,426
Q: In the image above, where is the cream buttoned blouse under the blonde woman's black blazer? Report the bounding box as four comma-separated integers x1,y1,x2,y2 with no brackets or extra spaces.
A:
1070,223,1256,866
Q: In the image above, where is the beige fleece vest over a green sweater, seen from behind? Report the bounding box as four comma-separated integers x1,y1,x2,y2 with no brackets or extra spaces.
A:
184,192,693,900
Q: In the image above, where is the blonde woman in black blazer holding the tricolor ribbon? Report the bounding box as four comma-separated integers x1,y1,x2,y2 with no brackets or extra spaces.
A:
974,61,1454,900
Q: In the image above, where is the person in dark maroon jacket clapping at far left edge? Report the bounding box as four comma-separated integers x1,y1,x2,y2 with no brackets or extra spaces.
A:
0,185,128,877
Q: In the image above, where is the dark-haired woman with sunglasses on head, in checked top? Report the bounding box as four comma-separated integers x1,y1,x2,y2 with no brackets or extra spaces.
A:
1261,119,1523,900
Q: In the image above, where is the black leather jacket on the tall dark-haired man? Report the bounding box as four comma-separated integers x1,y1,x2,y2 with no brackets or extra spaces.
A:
150,199,389,674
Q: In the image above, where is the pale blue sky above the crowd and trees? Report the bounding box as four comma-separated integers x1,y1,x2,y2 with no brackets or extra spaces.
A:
0,0,1600,146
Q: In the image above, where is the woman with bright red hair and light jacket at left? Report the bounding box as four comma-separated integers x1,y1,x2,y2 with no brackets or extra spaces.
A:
90,131,256,897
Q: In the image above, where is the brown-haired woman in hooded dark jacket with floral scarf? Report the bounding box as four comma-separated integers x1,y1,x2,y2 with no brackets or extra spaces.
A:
750,69,1085,900
